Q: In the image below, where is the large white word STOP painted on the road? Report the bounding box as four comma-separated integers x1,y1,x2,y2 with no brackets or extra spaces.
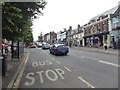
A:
24,68,65,86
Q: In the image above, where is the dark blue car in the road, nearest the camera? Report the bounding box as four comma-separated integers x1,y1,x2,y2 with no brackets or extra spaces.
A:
50,44,69,55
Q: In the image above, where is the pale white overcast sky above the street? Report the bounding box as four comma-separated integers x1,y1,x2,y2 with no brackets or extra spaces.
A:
32,0,120,40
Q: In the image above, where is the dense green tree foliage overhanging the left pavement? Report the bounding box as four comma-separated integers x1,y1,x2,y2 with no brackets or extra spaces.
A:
2,0,47,42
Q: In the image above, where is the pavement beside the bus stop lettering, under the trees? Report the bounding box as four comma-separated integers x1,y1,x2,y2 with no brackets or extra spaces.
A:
2,52,27,89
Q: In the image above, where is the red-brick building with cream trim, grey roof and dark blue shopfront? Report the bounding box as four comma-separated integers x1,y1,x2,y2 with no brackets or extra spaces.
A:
84,7,117,47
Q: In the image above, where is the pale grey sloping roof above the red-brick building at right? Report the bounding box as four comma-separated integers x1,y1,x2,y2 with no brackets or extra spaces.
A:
91,6,118,20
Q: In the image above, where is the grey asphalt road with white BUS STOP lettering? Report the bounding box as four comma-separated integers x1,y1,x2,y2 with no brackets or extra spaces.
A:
19,48,119,88
